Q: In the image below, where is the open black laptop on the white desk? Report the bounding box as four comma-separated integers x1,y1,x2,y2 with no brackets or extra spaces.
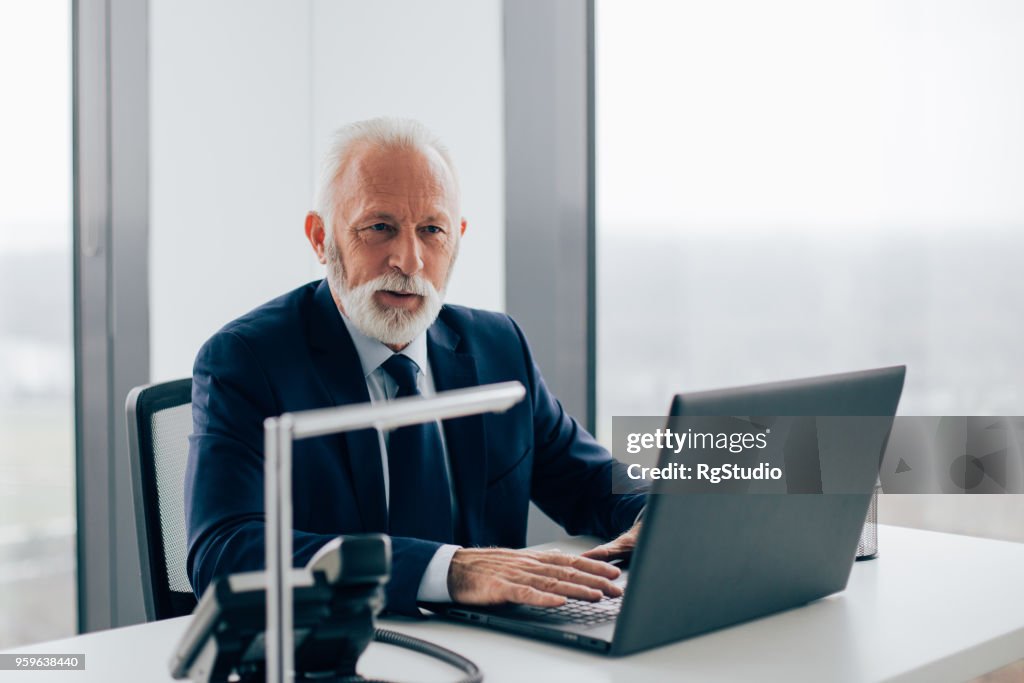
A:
423,366,905,656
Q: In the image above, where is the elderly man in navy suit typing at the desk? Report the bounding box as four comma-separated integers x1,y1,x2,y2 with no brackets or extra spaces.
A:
185,119,643,613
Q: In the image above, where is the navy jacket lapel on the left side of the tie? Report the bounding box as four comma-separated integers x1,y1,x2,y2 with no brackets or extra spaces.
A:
309,280,387,533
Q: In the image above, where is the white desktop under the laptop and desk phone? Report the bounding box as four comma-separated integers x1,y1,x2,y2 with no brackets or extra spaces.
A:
6,526,1024,683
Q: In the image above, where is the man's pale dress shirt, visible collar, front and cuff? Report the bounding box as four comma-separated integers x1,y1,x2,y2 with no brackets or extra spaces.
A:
339,311,462,602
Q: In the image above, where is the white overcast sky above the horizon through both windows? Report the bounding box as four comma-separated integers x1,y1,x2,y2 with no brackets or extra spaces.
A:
0,0,1024,250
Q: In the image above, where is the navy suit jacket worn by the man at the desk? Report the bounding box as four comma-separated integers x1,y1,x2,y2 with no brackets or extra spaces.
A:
184,281,643,613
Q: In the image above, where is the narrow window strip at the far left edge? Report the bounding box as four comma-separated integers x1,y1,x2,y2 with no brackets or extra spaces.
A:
0,0,76,648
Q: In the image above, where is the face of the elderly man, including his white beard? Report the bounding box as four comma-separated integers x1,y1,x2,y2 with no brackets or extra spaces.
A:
306,145,465,346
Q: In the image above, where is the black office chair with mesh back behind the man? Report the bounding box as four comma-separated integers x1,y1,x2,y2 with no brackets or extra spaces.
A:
125,379,196,622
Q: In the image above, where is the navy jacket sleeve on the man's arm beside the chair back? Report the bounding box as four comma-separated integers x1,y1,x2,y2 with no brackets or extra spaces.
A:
184,332,440,614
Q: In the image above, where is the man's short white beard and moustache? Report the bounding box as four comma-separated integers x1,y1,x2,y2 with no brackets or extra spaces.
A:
326,240,446,346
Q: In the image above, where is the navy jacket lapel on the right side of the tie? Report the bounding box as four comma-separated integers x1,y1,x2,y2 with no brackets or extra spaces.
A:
427,317,487,545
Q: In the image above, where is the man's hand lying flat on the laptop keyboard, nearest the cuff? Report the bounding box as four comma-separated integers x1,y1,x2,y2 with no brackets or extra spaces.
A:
449,548,623,607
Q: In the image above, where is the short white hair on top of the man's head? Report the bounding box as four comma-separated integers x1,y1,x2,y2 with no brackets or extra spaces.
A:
313,117,459,239
